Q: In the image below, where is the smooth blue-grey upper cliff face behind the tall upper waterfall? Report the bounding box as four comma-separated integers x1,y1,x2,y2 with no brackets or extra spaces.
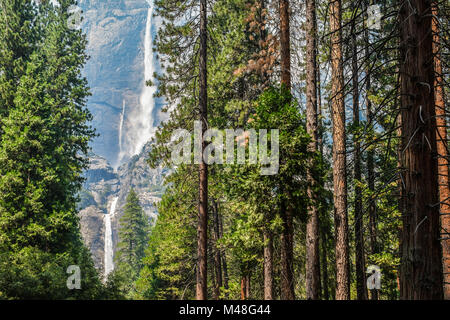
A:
80,0,162,168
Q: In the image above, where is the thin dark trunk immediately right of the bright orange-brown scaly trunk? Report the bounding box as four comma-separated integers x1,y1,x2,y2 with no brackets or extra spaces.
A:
351,18,367,300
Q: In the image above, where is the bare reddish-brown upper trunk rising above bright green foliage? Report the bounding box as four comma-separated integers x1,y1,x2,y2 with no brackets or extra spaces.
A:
280,0,291,90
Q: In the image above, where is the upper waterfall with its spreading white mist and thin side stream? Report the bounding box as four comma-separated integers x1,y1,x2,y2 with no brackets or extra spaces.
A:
117,0,156,165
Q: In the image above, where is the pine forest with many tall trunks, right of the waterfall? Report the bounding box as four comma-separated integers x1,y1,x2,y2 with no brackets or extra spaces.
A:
144,0,450,300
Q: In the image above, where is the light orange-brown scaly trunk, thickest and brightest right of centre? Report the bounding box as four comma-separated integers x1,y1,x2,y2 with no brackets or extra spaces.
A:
330,0,350,300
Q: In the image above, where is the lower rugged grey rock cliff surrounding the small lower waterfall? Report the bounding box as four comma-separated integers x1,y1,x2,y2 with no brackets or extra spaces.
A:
79,144,168,271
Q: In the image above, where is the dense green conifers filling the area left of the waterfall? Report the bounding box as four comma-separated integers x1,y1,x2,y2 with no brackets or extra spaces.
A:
0,0,101,299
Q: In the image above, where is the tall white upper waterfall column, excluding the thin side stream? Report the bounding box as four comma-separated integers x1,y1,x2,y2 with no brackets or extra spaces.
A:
132,0,156,154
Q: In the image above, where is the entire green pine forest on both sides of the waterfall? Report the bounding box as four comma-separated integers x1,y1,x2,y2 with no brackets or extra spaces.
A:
0,0,450,300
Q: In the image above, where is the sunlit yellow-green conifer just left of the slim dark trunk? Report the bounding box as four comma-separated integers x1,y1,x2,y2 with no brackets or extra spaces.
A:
136,170,198,300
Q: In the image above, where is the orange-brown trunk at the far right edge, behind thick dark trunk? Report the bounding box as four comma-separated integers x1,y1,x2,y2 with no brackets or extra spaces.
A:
432,2,450,300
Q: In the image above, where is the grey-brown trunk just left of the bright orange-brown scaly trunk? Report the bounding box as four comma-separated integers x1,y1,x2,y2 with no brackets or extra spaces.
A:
306,0,320,300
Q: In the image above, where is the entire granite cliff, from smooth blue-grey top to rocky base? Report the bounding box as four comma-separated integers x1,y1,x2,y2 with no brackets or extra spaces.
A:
79,0,166,271
